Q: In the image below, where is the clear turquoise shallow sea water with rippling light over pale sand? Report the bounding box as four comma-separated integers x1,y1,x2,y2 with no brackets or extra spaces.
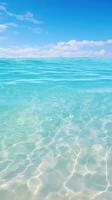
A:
0,59,112,200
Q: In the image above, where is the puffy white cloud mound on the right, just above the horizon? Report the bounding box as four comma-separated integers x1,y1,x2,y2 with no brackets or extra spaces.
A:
44,40,112,57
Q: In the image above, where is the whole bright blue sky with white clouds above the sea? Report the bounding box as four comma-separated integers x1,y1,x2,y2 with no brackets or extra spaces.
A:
0,0,112,57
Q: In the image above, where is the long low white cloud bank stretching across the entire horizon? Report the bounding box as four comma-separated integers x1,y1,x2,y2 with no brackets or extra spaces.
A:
0,39,112,58
